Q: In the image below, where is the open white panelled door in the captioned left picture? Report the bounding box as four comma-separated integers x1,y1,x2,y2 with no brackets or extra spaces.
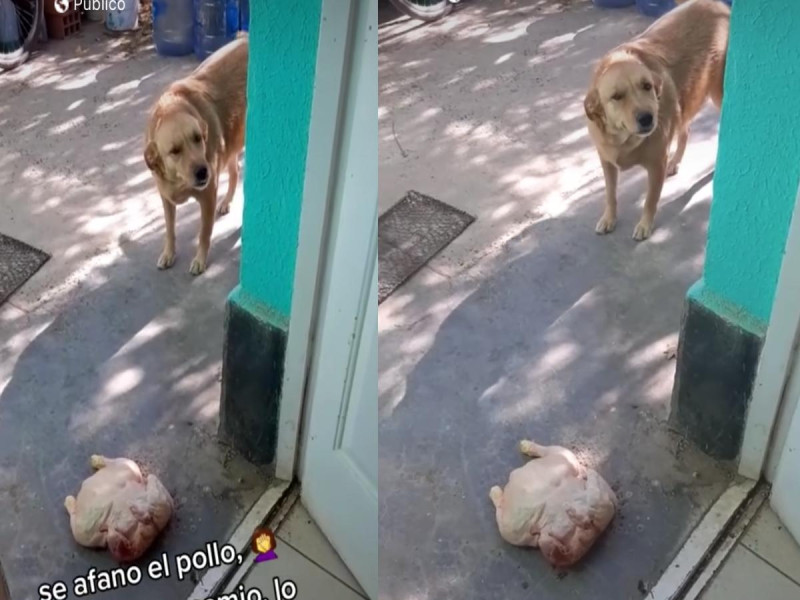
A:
301,0,378,598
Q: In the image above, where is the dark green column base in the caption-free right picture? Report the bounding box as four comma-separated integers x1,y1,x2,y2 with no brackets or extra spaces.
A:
670,296,762,460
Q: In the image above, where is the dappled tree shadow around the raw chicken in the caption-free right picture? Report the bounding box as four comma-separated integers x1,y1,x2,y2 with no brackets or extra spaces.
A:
379,168,729,600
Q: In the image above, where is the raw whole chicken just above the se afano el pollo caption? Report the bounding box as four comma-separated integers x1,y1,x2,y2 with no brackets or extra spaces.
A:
64,454,174,562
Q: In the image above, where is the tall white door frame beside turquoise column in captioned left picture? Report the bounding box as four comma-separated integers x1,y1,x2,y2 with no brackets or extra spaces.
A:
275,0,356,480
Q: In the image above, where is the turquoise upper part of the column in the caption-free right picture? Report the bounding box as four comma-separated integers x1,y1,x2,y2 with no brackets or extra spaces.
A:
694,0,800,323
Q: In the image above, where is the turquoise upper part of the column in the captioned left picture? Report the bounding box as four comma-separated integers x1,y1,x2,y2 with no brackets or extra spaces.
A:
237,0,321,321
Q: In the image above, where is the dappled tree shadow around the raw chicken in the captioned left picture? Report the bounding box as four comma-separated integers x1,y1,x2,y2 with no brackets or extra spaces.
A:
0,213,266,599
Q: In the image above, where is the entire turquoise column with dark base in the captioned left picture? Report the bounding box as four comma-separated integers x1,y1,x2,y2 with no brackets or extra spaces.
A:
220,0,321,463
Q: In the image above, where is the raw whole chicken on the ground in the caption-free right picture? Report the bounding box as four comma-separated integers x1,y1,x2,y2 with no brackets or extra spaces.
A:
489,440,617,568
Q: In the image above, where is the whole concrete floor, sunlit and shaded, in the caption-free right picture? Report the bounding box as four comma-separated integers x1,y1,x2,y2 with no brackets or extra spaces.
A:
379,0,729,600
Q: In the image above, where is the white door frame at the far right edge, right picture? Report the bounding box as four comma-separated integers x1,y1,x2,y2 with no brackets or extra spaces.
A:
739,180,800,481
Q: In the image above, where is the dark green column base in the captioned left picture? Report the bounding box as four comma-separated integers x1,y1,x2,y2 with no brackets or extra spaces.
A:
220,299,287,464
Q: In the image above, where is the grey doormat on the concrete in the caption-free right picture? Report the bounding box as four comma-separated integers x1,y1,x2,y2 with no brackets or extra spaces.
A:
378,191,475,304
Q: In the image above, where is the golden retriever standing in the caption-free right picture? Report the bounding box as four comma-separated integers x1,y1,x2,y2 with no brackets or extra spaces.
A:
584,0,730,241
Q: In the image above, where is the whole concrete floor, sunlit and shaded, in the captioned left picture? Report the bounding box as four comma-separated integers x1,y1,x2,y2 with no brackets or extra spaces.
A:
0,25,269,600
